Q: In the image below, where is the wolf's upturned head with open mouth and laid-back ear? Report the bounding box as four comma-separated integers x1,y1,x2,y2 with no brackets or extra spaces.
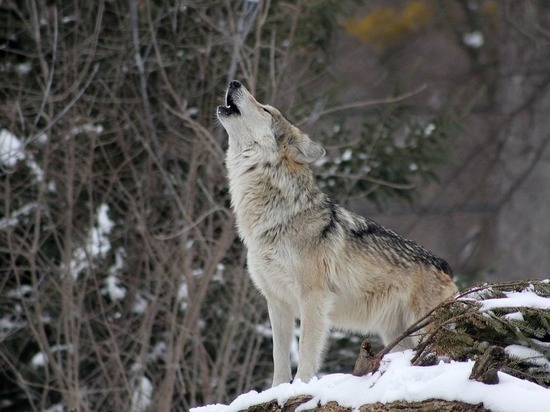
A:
217,80,325,164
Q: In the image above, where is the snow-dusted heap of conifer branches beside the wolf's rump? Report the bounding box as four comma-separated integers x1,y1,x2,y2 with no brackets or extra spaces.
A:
411,280,550,387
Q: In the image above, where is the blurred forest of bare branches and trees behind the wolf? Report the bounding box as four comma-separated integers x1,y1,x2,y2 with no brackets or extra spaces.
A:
0,0,550,412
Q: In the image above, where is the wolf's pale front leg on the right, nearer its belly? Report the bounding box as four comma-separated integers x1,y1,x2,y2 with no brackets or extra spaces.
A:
296,291,331,382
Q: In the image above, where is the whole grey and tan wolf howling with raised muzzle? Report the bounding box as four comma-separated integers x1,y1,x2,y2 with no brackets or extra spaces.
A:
217,80,458,386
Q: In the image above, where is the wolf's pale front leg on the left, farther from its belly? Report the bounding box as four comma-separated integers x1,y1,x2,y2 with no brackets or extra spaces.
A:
267,299,294,386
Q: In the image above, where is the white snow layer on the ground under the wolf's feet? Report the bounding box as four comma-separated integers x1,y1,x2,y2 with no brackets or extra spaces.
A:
191,351,550,412
